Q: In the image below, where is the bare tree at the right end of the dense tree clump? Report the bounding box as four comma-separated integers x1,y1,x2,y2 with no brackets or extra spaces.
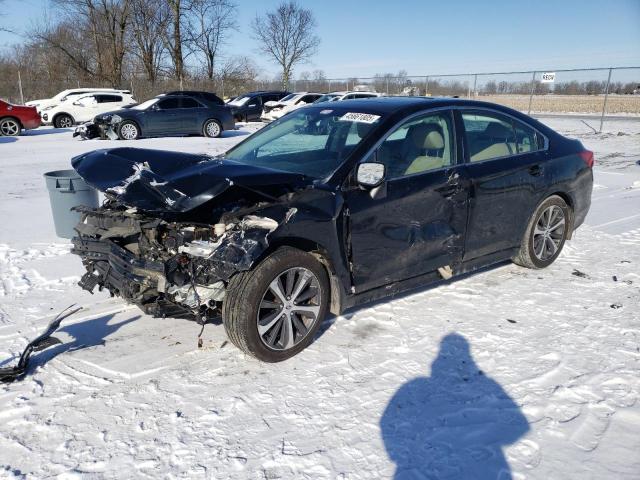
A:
190,0,238,80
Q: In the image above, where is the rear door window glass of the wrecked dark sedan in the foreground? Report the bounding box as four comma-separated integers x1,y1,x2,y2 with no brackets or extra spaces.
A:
462,112,518,162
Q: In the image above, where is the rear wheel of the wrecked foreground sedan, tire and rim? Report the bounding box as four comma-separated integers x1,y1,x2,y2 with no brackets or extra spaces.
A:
513,195,572,269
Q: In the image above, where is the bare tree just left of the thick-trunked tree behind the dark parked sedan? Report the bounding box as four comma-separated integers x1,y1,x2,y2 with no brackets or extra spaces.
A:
131,0,169,86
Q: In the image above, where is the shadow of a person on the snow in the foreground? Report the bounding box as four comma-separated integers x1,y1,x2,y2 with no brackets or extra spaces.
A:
380,334,529,480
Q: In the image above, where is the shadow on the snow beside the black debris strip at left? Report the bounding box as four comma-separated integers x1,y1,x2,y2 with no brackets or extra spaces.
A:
29,314,140,370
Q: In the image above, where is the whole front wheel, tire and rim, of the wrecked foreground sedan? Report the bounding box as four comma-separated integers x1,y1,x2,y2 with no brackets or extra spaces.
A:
222,247,330,362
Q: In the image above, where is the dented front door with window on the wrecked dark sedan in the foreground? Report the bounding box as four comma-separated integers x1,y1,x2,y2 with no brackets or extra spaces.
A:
345,110,468,293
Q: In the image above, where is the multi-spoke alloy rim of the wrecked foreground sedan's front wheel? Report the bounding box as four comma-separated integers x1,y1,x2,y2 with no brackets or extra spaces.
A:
257,267,322,350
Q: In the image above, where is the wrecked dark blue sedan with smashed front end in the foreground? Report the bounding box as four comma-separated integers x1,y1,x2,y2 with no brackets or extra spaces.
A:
73,97,593,362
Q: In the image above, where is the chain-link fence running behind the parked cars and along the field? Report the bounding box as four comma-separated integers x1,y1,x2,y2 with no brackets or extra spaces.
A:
5,67,640,131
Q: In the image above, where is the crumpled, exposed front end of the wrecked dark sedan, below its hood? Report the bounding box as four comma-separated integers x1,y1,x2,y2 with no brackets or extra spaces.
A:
72,202,286,317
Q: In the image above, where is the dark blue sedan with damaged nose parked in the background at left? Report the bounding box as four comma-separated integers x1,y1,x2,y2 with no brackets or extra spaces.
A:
76,94,235,140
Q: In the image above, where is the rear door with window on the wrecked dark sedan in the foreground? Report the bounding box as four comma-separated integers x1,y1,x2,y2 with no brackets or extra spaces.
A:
458,109,547,260
